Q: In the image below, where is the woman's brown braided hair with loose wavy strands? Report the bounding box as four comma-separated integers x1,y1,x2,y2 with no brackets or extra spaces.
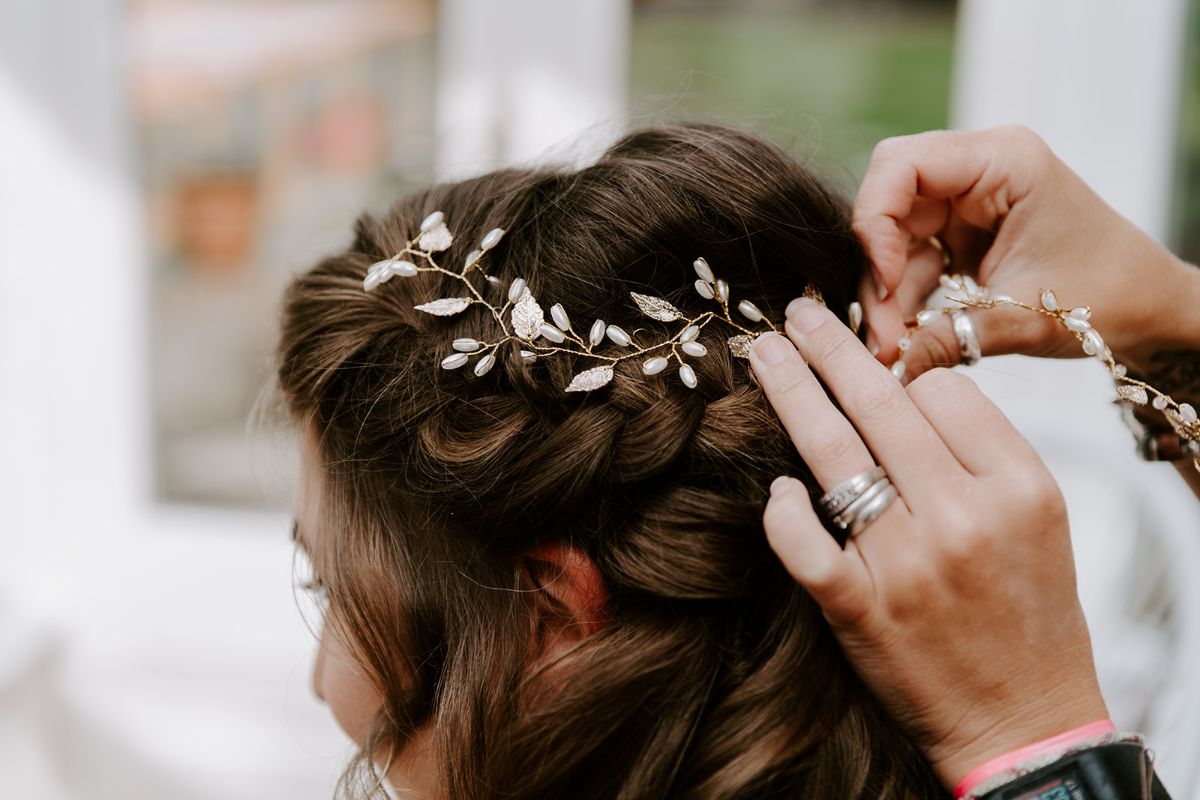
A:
278,125,942,799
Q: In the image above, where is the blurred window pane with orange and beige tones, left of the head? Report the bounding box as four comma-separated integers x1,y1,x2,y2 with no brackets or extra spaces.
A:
133,0,436,507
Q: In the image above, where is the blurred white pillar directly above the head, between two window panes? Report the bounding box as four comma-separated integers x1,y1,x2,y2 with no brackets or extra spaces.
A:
434,0,630,179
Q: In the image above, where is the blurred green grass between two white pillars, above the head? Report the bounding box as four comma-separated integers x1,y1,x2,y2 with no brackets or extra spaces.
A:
630,11,954,183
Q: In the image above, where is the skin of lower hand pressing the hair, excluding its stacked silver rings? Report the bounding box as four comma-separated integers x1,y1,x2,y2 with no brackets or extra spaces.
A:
750,299,1108,787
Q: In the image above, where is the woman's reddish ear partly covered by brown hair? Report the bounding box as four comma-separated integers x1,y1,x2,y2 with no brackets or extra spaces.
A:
522,542,608,656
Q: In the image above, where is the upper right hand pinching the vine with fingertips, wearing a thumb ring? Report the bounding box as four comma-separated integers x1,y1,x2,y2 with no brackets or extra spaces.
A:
853,126,1200,378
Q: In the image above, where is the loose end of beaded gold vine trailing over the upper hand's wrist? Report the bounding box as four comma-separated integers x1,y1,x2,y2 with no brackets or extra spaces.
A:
900,275,1200,471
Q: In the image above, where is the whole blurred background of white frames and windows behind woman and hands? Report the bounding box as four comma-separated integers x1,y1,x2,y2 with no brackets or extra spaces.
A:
0,0,1200,800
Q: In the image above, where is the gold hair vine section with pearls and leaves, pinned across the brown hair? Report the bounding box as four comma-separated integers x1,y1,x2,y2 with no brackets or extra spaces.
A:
362,211,811,392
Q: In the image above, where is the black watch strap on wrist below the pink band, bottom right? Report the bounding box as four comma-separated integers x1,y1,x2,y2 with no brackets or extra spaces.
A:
980,741,1170,800
